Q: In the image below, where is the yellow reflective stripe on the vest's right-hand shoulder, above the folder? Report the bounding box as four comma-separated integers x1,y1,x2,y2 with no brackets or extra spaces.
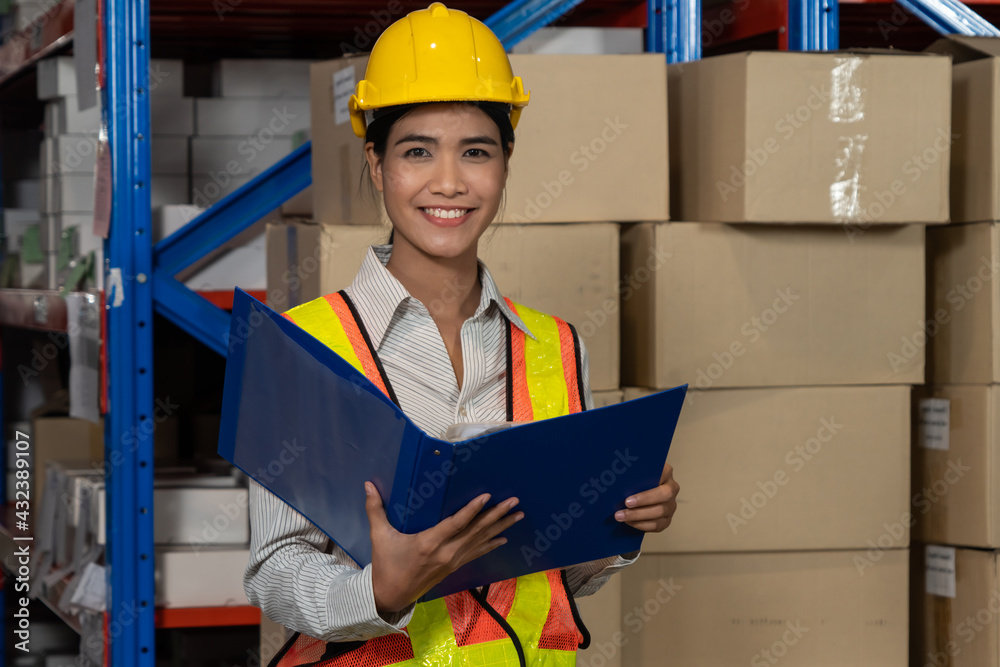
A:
517,304,582,421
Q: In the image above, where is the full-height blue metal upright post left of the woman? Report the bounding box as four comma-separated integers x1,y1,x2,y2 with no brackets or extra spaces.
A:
104,0,155,667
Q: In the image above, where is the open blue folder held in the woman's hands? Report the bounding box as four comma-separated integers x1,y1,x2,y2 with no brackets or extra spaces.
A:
219,289,687,601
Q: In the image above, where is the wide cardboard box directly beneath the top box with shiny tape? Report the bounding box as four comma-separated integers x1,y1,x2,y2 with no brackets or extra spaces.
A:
621,223,925,389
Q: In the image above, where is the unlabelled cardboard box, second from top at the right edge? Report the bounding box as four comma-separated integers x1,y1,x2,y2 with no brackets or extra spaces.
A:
922,222,1000,384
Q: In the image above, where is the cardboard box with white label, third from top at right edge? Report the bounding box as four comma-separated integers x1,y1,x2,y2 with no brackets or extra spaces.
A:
913,385,1000,549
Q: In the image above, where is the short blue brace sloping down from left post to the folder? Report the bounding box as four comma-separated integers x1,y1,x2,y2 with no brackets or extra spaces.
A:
153,269,232,357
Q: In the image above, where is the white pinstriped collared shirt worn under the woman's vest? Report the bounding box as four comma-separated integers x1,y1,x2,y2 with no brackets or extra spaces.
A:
243,245,639,641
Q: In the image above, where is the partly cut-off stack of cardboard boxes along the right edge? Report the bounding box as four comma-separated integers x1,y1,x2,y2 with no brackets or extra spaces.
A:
912,36,1000,667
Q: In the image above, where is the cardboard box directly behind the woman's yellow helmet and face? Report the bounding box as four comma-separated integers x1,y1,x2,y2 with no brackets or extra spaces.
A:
312,54,669,224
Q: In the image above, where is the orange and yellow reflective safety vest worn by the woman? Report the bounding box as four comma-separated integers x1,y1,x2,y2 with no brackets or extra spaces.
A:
269,290,590,667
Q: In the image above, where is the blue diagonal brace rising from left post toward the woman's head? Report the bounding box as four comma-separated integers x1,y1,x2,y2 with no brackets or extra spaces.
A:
153,143,312,276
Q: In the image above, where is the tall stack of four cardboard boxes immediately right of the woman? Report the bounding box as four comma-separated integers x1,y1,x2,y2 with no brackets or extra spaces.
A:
622,53,950,666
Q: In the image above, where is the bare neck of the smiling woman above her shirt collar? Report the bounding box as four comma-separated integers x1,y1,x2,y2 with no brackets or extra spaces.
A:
386,234,482,322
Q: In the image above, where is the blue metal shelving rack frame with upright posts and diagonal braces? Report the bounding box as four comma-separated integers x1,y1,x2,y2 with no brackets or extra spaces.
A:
35,0,1000,667
